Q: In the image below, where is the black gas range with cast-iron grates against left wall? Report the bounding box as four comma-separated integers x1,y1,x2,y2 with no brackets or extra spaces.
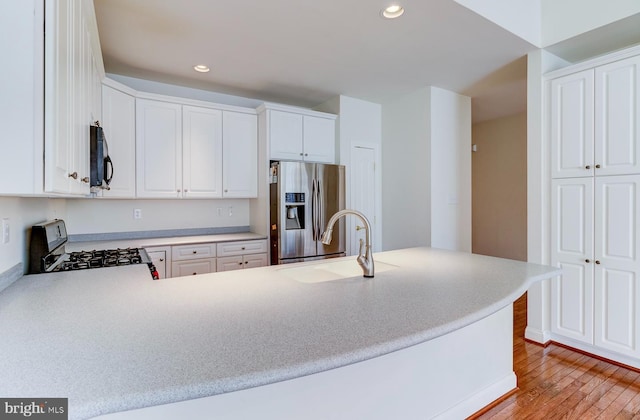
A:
29,220,158,279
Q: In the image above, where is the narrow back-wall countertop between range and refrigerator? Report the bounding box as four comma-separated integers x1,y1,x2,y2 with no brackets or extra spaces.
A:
65,232,267,252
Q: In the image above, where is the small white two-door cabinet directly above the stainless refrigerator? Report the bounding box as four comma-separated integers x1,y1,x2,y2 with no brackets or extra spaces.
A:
258,104,336,163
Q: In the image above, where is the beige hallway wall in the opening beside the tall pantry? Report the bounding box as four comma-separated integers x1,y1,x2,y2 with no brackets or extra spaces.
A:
471,113,527,261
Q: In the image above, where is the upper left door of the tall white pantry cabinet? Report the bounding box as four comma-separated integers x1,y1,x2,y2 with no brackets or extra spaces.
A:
551,70,594,178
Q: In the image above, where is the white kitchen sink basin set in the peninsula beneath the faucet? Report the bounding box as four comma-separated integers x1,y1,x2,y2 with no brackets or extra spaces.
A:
277,259,398,283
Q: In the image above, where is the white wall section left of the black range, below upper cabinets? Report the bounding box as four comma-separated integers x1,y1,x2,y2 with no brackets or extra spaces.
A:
0,197,66,273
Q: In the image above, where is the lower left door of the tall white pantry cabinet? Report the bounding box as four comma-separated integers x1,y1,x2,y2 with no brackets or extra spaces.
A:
551,178,594,344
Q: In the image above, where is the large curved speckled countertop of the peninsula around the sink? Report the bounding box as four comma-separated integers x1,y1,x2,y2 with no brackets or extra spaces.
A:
0,248,559,419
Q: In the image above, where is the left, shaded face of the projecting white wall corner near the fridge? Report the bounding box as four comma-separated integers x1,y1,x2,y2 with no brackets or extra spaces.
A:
382,88,431,250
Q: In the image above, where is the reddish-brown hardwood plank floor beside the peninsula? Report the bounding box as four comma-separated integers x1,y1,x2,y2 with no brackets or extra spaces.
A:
471,294,640,420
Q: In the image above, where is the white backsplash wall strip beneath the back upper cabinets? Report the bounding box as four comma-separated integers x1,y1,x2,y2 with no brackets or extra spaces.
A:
66,199,250,235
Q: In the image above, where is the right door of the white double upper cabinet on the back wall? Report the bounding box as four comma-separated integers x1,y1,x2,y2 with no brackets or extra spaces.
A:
182,106,222,198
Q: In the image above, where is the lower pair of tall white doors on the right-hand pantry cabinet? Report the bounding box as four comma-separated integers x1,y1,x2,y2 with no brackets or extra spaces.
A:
551,175,640,358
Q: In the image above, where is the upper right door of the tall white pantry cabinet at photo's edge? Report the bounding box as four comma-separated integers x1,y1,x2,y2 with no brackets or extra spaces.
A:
595,57,640,175
